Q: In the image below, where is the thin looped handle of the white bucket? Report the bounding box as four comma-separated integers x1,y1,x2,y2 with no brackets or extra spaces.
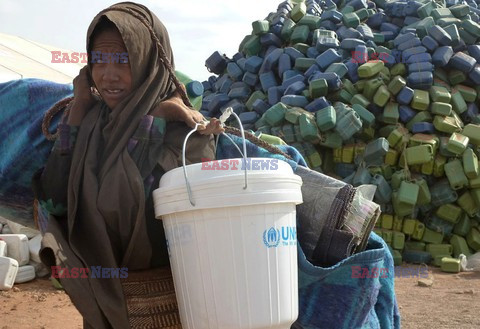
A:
182,107,248,207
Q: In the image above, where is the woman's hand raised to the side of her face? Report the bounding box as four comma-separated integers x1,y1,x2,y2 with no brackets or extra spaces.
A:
67,65,96,126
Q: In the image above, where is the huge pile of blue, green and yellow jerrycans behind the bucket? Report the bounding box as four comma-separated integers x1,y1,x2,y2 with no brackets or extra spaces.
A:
201,0,480,272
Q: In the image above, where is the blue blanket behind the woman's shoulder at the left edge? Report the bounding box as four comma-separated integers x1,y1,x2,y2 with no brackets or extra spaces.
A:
0,79,73,226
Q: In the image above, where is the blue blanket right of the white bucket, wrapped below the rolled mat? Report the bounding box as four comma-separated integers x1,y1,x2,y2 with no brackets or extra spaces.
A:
217,135,400,329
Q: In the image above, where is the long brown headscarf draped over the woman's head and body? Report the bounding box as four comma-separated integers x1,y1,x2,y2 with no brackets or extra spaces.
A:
40,2,213,328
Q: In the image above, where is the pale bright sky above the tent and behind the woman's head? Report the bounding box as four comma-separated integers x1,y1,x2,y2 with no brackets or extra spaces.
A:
0,0,282,81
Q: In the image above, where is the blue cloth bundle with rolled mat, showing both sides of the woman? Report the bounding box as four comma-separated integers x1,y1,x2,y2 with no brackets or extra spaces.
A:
0,79,400,329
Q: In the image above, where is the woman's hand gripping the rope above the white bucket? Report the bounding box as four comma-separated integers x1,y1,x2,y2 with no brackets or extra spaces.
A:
152,93,224,135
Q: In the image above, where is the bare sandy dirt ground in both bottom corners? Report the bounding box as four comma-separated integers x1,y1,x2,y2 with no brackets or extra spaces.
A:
0,265,480,329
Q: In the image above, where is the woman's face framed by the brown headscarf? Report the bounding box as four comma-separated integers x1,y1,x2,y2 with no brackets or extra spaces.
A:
91,29,132,109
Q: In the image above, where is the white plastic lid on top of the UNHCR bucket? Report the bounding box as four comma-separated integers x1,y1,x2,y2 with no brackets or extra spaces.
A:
153,158,303,218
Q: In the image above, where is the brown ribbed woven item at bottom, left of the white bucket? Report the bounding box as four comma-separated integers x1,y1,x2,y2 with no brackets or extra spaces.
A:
122,267,182,329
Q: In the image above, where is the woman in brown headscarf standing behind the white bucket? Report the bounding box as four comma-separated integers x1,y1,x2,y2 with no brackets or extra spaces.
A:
34,2,222,328
